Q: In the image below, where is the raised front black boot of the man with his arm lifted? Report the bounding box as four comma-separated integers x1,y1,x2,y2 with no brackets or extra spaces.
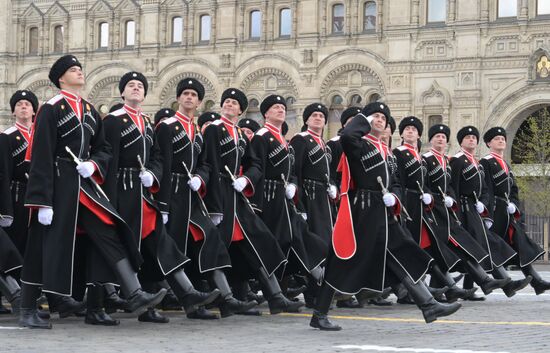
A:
402,276,462,324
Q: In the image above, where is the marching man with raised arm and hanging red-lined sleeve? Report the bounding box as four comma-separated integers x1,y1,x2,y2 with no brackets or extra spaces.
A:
310,103,460,330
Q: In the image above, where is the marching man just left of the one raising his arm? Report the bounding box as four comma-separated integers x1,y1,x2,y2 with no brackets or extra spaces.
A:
290,103,338,244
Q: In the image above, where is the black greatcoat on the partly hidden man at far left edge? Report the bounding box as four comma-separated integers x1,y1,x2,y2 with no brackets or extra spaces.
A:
0,124,30,254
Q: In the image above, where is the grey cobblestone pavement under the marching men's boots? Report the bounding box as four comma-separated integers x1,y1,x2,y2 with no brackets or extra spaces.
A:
0,271,550,353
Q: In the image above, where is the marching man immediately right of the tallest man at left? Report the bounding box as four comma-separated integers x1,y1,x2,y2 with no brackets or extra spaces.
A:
104,72,219,323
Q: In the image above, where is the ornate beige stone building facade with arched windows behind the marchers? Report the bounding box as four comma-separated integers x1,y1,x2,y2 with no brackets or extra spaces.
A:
0,0,550,155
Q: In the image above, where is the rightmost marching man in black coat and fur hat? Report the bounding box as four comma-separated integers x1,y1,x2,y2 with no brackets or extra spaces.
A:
480,127,550,295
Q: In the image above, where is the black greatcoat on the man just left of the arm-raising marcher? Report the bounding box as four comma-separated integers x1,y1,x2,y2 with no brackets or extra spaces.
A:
290,131,334,244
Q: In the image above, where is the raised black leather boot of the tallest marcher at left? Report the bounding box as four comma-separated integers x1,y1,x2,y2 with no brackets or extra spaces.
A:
115,259,166,313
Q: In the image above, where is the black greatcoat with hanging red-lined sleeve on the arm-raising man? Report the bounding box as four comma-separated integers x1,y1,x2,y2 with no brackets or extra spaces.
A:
325,115,432,294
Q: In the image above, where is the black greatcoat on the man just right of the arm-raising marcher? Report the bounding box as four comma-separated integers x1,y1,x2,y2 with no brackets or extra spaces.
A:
393,145,460,271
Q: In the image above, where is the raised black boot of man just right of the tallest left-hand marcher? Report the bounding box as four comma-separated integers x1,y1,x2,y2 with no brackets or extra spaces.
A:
166,269,220,314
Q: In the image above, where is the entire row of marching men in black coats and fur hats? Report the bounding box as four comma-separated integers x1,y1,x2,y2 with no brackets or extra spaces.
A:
0,55,550,330
